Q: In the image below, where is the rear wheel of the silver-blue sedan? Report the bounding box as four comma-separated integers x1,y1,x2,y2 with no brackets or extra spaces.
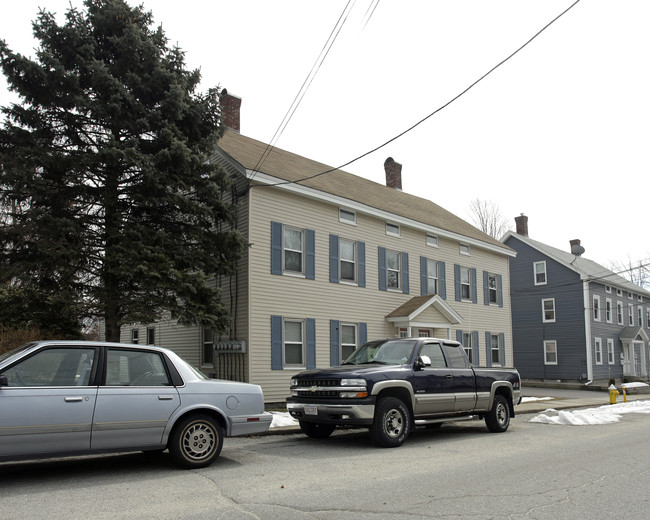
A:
168,414,223,468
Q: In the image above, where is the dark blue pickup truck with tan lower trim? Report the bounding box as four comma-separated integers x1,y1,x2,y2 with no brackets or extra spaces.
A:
287,338,521,447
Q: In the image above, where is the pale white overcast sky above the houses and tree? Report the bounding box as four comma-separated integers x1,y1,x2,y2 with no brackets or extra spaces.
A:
0,0,650,267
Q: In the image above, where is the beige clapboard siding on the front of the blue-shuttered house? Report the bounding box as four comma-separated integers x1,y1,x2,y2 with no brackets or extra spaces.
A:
249,188,513,402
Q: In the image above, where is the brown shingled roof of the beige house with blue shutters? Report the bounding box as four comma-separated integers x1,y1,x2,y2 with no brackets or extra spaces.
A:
217,130,514,256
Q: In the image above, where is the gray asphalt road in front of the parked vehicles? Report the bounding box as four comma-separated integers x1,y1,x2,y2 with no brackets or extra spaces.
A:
0,406,650,520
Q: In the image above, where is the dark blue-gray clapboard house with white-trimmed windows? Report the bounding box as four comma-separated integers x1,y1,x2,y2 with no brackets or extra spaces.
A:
502,215,650,384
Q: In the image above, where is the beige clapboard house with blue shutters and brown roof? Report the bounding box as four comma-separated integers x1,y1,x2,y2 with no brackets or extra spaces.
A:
115,94,514,402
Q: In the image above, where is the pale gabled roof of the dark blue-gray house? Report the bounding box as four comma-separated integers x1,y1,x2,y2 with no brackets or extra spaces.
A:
501,231,650,297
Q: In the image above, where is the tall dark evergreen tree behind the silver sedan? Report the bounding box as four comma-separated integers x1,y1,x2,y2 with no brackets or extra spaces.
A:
0,0,245,340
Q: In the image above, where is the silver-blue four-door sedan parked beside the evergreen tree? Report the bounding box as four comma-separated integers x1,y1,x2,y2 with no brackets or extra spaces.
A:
0,341,272,468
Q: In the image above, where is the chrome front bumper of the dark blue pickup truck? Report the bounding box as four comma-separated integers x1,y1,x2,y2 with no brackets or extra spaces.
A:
287,399,375,426
